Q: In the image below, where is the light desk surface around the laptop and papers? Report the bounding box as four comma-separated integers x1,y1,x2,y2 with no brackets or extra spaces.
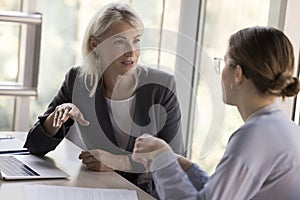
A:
0,132,154,200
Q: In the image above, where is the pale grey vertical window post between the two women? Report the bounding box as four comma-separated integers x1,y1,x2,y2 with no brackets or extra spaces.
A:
175,0,205,158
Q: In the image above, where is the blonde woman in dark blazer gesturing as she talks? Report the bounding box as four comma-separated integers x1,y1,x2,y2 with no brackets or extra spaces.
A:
25,3,183,195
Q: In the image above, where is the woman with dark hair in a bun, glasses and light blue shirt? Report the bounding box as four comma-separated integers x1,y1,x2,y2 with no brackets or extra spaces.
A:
133,27,300,200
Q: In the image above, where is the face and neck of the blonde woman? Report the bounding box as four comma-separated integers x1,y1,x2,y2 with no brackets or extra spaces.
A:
96,21,141,99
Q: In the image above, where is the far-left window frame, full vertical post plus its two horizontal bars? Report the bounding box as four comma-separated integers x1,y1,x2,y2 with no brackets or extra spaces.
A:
0,0,42,131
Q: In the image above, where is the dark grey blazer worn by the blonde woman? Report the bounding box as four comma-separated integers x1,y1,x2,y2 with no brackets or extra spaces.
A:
24,67,183,155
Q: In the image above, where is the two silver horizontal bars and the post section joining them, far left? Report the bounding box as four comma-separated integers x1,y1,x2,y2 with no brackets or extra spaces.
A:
0,11,42,96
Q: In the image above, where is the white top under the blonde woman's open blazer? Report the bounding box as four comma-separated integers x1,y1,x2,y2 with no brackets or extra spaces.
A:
106,95,135,149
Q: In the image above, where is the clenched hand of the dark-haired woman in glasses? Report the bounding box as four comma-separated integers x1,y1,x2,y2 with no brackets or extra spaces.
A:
132,134,172,168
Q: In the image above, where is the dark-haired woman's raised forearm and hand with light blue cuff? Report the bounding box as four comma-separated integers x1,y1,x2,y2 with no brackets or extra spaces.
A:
133,135,197,199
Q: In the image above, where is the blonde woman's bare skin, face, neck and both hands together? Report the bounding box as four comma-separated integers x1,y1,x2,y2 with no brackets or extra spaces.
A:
43,21,141,171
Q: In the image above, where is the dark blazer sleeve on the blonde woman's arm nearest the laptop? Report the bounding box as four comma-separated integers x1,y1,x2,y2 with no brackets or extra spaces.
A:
24,68,79,156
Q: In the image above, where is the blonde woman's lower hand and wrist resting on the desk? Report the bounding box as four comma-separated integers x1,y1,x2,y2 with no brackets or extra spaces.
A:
79,149,131,171
